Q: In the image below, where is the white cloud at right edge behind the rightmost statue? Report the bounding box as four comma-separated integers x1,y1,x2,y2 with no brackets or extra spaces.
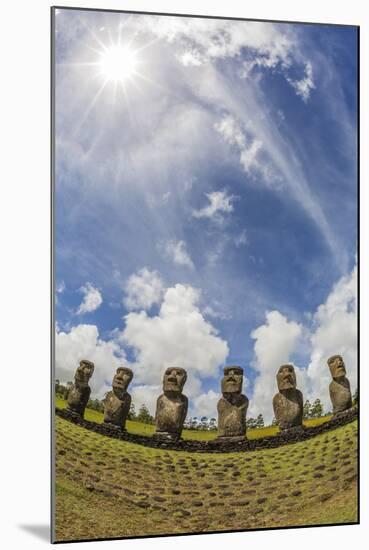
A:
307,266,358,409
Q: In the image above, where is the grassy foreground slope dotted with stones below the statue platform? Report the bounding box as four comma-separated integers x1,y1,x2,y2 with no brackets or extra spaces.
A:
56,418,357,541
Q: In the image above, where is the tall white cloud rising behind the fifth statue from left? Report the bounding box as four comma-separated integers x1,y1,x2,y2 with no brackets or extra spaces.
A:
248,311,302,422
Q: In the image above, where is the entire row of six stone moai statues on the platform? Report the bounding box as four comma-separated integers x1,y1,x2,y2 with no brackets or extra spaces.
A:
67,355,352,440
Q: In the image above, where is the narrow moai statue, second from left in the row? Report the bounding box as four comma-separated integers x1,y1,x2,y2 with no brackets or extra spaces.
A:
104,367,133,430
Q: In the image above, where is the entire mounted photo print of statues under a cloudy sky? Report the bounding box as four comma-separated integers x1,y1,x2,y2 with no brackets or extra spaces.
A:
52,7,359,542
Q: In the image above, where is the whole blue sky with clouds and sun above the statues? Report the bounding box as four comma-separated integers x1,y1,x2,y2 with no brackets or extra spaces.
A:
55,9,357,417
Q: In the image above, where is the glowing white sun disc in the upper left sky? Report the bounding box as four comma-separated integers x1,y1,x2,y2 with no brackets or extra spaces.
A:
98,46,138,83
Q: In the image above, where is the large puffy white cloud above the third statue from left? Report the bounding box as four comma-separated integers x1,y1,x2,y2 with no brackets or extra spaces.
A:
121,284,228,390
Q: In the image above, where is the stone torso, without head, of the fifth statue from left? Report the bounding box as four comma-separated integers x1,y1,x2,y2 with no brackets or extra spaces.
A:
273,389,304,430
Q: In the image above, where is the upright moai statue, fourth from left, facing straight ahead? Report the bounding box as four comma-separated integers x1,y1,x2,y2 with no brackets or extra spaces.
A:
217,367,249,439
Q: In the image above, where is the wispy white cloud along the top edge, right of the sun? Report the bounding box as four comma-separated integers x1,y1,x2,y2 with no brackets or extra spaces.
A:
141,18,315,102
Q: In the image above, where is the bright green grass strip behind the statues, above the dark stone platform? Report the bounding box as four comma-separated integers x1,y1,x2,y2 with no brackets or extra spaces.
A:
55,397,332,441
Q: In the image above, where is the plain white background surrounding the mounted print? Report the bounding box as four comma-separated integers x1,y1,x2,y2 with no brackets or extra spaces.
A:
0,0,369,550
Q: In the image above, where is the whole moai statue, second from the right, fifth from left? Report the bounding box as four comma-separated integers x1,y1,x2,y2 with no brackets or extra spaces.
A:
273,365,304,430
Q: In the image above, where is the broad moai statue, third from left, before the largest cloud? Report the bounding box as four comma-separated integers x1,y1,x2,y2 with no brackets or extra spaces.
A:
155,367,188,439
